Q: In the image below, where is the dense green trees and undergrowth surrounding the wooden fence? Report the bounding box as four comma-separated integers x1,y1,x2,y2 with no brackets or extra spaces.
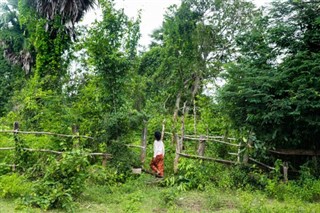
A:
0,0,320,210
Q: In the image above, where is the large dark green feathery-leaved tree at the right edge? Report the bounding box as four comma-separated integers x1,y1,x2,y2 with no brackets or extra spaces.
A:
220,1,320,153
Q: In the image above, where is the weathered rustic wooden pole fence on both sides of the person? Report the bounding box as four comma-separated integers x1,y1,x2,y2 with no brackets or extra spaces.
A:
0,120,320,181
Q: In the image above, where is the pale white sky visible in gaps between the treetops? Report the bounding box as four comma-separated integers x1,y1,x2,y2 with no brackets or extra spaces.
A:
84,0,271,47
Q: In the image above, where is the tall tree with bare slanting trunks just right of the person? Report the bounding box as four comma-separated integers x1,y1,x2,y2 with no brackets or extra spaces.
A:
140,0,256,136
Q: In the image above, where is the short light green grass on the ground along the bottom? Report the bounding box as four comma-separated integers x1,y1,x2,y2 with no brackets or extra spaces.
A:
0,174,320,213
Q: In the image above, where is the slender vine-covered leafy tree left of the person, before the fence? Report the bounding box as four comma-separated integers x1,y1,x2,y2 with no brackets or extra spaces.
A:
78,0,140,142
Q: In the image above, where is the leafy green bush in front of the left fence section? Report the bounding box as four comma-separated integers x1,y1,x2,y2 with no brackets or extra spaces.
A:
23,151,88,210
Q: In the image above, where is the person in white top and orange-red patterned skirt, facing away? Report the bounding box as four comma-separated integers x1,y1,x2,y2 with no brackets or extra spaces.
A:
150,131,165,177
